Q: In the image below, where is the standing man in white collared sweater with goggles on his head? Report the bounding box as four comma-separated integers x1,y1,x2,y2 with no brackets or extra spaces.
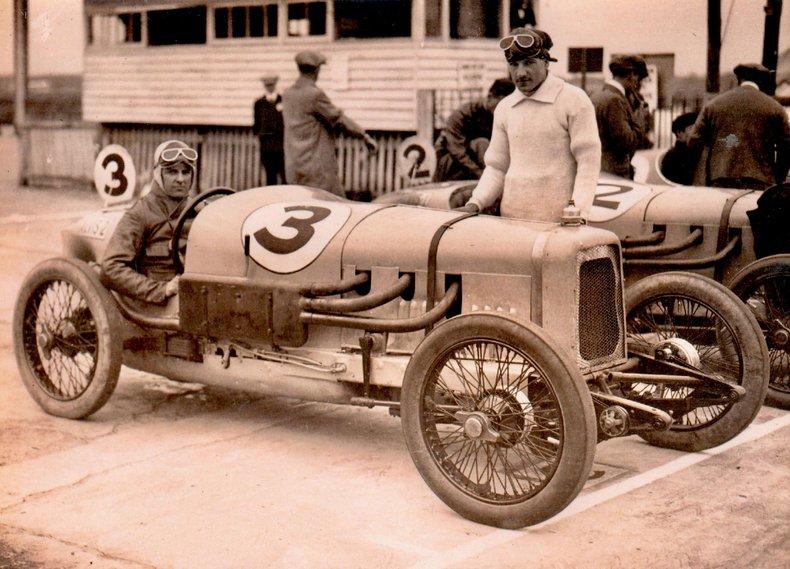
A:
463,28,601,222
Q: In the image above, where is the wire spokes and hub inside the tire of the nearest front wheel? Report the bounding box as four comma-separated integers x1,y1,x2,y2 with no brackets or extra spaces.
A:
422,340,564,504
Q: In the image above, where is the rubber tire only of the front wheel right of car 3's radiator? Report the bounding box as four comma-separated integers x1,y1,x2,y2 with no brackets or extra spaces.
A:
625,272,769,452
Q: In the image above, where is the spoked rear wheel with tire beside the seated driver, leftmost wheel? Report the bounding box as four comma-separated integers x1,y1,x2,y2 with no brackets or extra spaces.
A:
13,259,123,419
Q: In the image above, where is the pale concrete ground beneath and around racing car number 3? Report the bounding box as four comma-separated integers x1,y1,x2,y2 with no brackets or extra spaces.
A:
0,133,790,568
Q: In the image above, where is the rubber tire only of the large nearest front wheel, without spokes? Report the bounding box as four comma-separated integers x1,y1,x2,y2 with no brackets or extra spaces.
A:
401,314,597,529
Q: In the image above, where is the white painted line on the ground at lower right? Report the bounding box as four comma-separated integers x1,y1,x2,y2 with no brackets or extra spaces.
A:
411,413,790,569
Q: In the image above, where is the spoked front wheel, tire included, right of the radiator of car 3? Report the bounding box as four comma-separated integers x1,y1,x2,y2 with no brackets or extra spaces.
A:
626,272,768,451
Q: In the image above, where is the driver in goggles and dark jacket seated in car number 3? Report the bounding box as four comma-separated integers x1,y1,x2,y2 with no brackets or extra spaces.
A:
101,140,197,305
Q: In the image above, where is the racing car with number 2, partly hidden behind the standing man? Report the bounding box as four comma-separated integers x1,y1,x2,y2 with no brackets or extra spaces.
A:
377,178,790,409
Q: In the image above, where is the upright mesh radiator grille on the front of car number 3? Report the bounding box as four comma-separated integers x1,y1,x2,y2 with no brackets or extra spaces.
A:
576,245,625,368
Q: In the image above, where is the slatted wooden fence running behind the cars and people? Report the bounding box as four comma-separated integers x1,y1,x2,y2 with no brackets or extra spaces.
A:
22,90,702,190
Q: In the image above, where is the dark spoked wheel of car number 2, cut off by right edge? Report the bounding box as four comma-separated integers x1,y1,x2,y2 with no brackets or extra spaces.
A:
730,255,790,409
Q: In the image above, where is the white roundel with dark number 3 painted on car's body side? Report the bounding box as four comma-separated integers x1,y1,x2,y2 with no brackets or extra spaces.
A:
241,201,351,273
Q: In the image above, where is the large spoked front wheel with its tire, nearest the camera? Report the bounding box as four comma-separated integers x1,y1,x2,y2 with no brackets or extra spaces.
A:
401,314,596,528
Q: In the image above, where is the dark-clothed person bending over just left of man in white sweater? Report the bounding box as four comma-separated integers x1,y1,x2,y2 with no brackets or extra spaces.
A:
433,77,515,182
